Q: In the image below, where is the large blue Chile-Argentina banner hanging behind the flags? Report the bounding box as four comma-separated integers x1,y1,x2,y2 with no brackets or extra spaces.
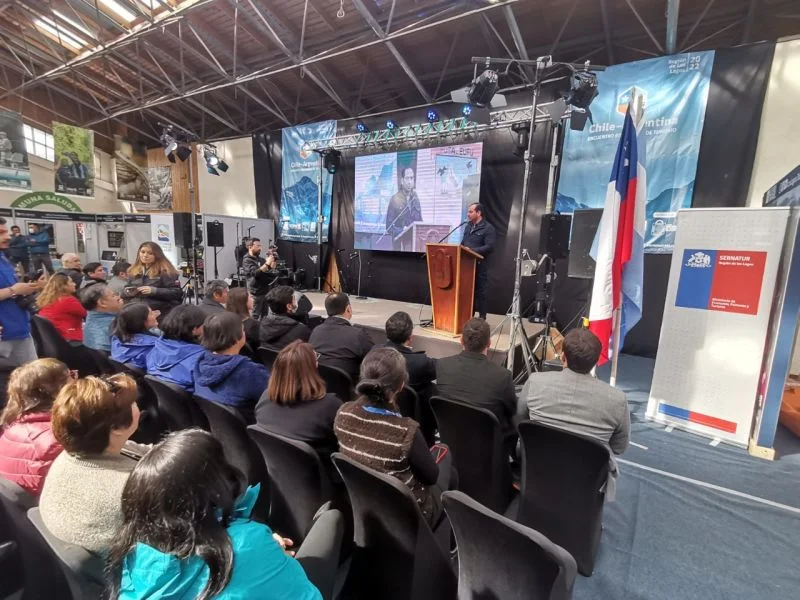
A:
556,51,714,254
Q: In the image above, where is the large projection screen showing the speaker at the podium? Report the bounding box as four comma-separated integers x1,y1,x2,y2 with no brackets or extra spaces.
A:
355,142,483,252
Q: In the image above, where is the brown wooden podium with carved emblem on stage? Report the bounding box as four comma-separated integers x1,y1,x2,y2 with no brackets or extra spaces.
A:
425,244,483,335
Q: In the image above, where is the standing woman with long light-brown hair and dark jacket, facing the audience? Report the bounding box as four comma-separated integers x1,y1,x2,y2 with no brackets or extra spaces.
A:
122,242,183,319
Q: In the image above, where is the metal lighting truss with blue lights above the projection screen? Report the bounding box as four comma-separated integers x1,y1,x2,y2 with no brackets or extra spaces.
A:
306,99,571,150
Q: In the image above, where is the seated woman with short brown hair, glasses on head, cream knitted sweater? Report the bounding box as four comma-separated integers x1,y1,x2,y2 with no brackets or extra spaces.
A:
39,375,146,554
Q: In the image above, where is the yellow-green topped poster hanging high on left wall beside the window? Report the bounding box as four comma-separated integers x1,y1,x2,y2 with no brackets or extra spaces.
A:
53,121,94,197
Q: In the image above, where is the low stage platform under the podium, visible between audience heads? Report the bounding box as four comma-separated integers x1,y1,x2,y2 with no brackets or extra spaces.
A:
305,292,542,363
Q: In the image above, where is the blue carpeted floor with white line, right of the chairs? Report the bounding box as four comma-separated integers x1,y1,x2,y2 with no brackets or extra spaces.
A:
574,356,800,600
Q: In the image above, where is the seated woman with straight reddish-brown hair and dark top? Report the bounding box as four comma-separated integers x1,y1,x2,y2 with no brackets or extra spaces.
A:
256,340,342,458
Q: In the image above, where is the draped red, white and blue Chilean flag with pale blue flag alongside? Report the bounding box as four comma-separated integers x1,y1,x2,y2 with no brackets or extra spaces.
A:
589,101,647,364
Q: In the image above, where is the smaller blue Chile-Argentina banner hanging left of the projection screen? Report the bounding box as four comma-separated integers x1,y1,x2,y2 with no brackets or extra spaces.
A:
278,121,336,242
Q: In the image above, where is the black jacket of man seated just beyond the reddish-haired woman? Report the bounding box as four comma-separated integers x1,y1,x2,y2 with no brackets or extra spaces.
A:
308,317,373,382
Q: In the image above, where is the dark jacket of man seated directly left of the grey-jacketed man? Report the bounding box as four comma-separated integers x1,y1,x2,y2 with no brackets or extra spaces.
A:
436,351,517,434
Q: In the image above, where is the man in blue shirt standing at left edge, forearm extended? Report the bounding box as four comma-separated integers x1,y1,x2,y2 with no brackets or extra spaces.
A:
0,217,45,398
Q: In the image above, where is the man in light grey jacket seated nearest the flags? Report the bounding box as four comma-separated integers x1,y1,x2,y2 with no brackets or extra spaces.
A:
518,328,631,454
